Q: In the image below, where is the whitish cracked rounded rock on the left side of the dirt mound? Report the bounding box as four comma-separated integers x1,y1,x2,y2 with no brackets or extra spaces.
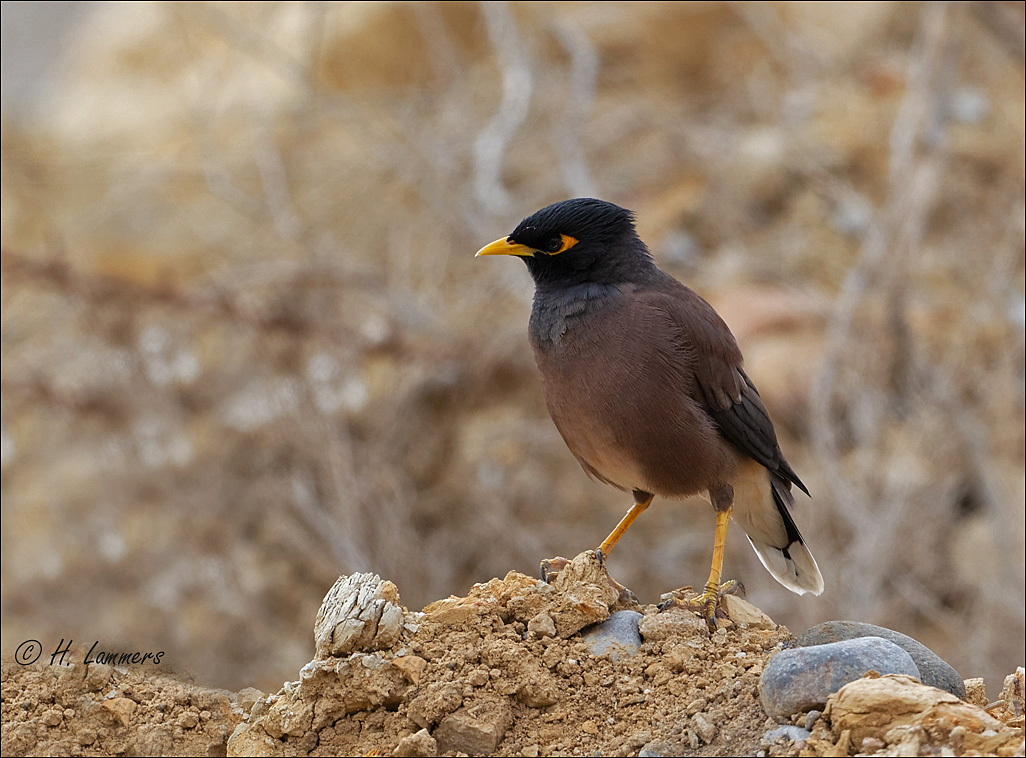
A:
314,573,404,657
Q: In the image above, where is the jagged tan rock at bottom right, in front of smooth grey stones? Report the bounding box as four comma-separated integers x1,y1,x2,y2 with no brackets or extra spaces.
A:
827,675,1022,755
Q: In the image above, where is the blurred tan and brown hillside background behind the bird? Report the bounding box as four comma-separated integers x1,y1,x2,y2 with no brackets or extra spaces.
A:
0,2,1026,696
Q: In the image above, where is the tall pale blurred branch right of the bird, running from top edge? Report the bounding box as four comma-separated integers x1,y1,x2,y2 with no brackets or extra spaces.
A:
811,3,957,611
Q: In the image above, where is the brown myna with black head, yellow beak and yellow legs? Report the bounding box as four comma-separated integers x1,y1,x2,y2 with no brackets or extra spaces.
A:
477,198,824,631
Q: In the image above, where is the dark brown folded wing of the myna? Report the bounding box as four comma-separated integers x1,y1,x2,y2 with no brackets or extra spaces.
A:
646,277,808,494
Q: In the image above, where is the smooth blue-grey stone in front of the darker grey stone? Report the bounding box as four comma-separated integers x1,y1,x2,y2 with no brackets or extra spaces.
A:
760,637,919,721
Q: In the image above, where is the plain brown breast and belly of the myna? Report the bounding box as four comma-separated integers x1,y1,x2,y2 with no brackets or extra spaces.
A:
535,296,739,497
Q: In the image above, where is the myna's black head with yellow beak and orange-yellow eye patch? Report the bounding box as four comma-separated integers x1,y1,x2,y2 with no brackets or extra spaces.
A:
477,198,654,287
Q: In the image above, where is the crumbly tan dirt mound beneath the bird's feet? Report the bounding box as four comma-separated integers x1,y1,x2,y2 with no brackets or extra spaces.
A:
230,553,789,755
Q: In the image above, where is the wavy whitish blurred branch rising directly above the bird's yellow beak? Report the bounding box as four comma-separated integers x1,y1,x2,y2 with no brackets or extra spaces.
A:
474,1,534,212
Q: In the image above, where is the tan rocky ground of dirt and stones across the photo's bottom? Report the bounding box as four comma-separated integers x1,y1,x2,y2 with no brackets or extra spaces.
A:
2,553,1024,756
